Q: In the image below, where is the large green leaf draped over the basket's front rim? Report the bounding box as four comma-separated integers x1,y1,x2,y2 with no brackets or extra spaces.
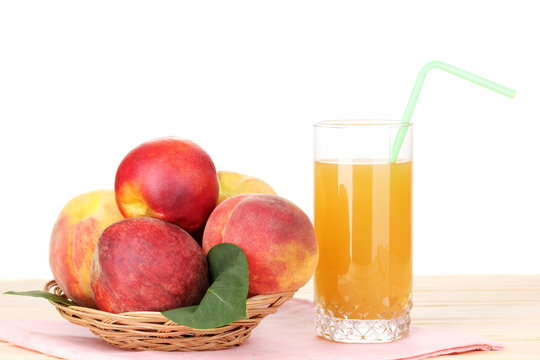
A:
162,243,249,329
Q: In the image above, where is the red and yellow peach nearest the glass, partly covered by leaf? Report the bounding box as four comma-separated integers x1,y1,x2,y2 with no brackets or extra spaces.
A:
203,194,319,295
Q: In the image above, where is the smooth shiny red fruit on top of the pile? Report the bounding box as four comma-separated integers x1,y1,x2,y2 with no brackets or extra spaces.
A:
114,137,219,232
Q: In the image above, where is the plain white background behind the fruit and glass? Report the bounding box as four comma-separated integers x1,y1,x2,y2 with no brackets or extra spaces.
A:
0,0,540,278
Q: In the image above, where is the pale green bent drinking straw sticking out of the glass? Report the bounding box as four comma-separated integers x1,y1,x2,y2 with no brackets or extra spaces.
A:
390,60,516,162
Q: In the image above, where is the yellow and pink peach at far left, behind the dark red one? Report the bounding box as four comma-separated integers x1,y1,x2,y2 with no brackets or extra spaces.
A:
49,190,123,307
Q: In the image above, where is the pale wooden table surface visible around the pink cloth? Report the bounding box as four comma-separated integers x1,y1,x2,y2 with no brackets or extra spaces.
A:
0,274,540,360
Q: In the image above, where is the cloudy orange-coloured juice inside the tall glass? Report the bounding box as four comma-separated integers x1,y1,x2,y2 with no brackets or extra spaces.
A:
315,160,412,320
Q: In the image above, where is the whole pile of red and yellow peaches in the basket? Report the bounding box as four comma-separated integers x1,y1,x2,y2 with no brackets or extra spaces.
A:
49,137,318,313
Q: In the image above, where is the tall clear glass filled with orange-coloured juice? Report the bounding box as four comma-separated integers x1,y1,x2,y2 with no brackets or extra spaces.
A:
314,120,412,343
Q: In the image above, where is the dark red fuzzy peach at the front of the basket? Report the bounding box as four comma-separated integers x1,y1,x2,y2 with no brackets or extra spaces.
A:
90,217,208,313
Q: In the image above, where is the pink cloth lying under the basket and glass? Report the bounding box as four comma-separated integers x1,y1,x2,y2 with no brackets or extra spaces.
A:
0,299,502,360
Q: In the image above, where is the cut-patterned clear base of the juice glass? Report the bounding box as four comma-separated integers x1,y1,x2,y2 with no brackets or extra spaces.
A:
315,299,412,343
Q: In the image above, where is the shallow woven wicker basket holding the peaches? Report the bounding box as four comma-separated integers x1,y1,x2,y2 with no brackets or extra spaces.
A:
45,280,295,351
